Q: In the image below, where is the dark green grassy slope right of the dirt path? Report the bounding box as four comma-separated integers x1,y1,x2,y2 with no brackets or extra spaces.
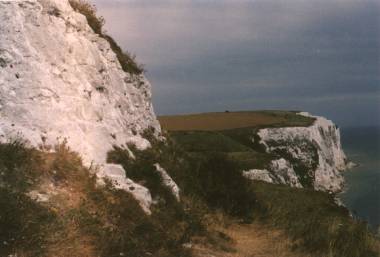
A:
252,182,379,257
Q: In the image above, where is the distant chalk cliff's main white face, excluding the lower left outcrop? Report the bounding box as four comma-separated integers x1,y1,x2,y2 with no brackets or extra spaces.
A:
258,113,346,192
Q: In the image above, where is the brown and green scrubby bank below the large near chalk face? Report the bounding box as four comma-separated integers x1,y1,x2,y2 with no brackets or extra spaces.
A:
0,141,200,257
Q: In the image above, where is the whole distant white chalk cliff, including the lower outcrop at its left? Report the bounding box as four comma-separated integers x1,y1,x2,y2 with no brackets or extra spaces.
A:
255,113,347,192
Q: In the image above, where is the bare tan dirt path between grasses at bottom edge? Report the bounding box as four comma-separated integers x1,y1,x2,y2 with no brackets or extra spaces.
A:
193,223,309,257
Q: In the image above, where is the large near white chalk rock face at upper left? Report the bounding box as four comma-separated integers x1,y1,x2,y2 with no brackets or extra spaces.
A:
0,0,160,210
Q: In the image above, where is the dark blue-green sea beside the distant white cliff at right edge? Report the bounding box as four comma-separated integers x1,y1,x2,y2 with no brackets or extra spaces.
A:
340,127,380,231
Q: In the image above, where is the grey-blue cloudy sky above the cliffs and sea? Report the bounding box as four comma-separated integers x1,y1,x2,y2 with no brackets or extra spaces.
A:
93,0,380,126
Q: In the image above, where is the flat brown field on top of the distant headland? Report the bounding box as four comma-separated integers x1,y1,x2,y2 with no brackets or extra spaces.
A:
158,111,314,131
